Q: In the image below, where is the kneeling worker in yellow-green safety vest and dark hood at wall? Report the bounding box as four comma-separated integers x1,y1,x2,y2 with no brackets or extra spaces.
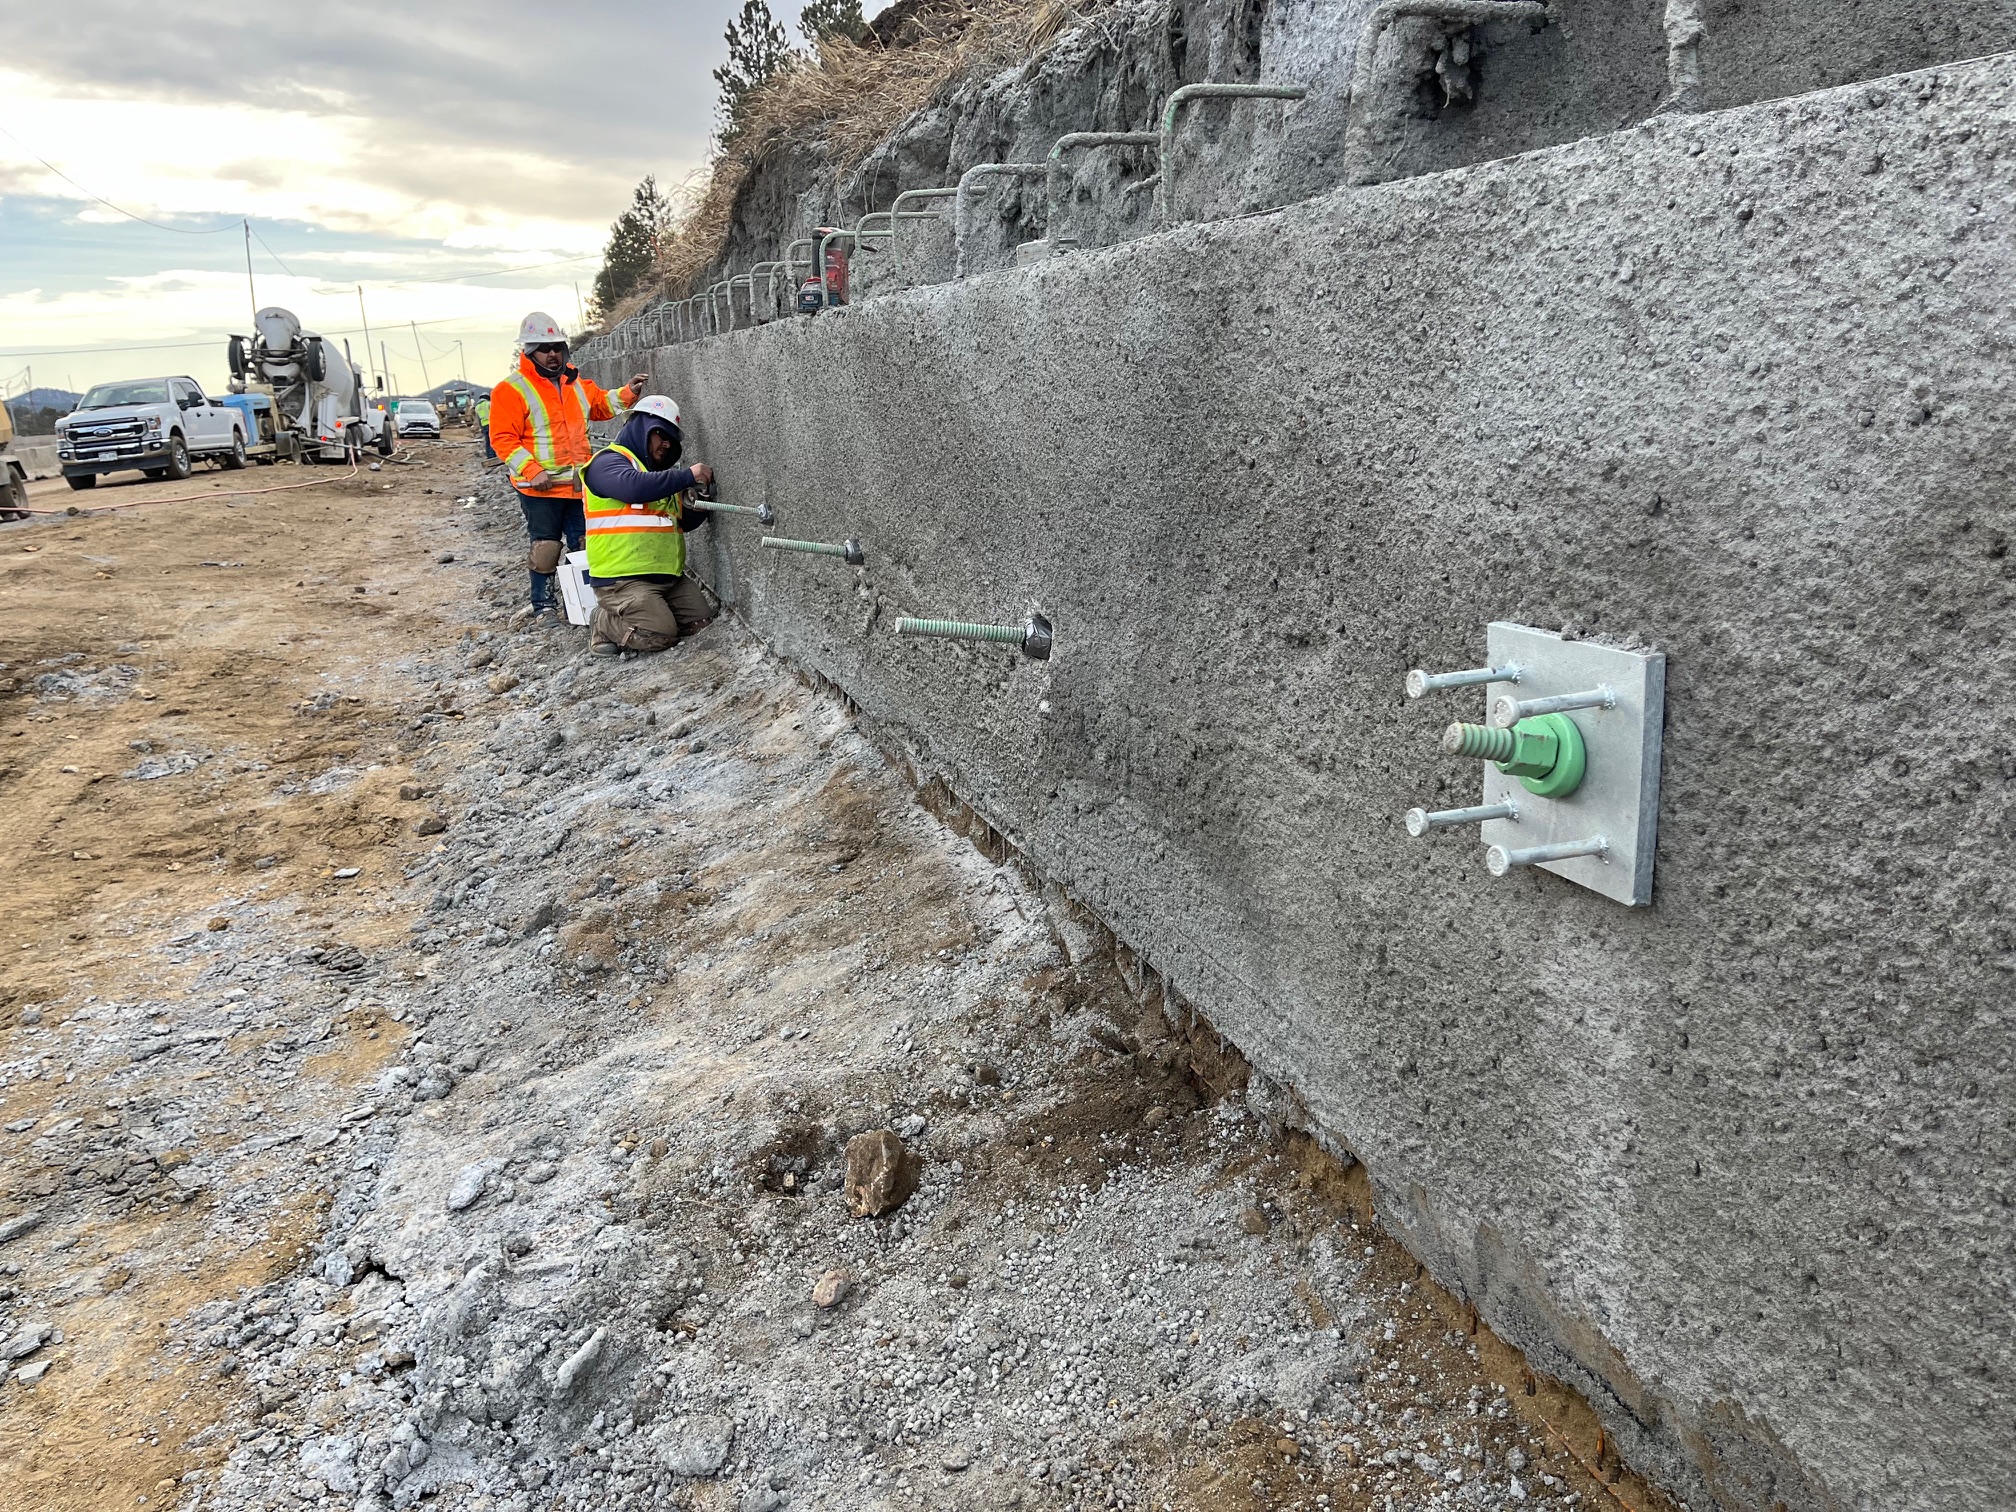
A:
583,393,714,657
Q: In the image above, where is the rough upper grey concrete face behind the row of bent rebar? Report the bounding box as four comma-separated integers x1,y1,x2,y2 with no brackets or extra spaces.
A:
708,0,2016,296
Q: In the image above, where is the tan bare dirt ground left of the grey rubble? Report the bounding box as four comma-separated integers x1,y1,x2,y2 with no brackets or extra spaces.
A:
0,448,473,1508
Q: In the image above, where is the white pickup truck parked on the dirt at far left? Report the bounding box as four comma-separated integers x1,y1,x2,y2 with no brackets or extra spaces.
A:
56,377,248,488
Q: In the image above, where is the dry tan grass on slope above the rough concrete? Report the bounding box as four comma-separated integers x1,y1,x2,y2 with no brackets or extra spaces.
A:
641,0,1107,304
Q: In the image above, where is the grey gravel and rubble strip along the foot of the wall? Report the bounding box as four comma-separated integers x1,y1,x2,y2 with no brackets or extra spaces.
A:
0,459,1669,1512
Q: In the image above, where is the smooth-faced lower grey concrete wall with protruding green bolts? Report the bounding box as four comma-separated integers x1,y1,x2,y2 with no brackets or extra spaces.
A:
603,54,2016,1512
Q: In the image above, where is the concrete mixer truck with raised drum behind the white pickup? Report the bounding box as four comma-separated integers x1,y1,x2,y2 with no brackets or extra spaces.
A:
228,304,393,462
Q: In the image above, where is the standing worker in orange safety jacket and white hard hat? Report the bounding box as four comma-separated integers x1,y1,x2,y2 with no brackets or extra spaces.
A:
490,310,645,623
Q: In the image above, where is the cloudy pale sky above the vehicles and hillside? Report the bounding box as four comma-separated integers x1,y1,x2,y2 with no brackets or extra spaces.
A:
0,0,800,393
